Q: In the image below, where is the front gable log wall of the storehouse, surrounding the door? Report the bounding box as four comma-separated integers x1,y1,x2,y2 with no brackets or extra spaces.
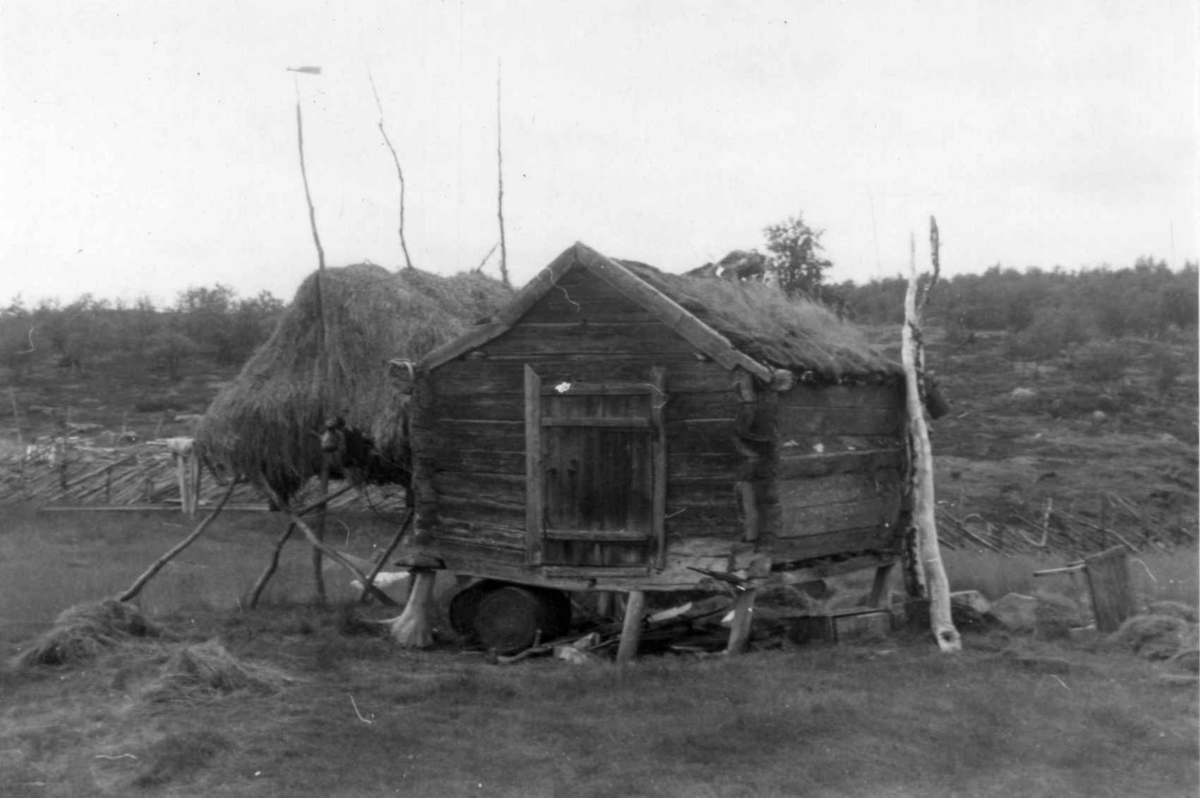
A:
410,269,745,576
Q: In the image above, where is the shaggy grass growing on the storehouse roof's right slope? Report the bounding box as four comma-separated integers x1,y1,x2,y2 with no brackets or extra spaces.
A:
622,260,899,379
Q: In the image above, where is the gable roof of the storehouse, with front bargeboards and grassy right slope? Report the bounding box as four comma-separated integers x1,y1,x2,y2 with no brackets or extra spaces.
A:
420,242,899,383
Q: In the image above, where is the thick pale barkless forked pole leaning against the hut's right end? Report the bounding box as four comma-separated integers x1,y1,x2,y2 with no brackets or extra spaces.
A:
901,218,962,653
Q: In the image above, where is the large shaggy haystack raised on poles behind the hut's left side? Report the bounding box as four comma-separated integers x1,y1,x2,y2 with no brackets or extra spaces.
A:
196,264,511,494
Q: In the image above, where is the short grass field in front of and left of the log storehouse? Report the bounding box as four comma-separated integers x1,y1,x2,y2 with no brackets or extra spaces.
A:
0,511,1200,797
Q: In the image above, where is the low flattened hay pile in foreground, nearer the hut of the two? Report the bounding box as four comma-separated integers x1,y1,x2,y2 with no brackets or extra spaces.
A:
142,640,295,703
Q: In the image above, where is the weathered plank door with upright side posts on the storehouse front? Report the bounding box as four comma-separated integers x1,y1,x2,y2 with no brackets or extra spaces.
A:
526,366,666,574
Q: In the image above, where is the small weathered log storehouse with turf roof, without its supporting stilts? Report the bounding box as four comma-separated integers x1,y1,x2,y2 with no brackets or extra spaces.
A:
401,237,907,628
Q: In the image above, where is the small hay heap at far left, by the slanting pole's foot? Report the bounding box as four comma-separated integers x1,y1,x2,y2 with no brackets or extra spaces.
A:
14,599,162,668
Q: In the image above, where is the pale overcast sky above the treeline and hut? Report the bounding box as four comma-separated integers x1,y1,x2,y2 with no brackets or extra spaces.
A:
0,0,1200,301
